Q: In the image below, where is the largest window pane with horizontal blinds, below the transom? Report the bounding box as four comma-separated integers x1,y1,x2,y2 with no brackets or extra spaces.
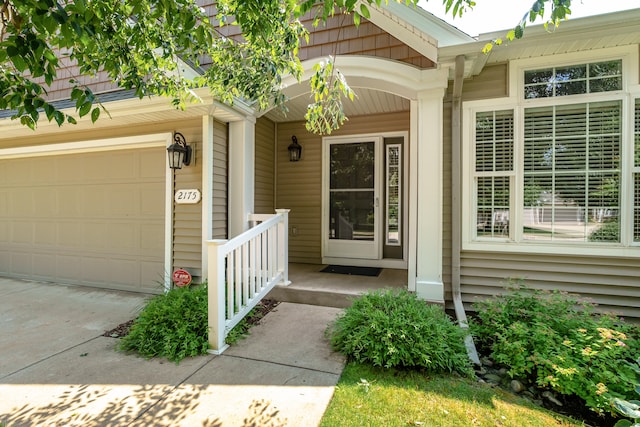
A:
523,101,622,242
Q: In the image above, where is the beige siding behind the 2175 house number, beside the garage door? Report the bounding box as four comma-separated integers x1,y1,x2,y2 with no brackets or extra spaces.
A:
171,121,202,283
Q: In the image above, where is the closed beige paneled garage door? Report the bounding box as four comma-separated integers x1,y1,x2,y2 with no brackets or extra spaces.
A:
0,147,166,292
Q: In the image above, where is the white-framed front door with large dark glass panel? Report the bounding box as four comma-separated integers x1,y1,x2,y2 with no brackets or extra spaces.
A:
323,137,381,260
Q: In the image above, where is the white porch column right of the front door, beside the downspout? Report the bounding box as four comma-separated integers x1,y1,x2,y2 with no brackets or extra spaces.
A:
409,88,445,303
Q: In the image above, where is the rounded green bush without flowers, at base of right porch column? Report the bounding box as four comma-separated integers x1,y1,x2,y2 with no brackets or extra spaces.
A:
327,290,473,375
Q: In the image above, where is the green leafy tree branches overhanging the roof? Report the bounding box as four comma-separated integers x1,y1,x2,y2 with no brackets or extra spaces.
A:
0,0,571,133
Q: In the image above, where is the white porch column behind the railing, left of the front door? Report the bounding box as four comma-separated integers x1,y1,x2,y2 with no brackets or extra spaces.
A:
229,117,255,238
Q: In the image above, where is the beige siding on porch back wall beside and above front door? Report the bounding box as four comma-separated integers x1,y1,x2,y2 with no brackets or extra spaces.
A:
276,112,409,264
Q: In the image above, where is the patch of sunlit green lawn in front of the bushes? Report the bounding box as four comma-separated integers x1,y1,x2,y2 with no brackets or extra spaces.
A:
320,363,583,427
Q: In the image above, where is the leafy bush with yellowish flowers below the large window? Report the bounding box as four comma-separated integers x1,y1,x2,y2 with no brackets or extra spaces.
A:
471,286,640,413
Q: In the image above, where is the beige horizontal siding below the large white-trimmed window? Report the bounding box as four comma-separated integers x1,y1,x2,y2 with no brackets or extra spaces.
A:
461,251,640,318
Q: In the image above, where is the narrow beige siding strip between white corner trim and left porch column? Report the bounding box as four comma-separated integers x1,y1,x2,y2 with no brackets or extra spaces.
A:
213,120,229,239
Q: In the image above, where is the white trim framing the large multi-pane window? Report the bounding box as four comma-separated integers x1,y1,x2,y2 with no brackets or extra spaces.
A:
461,45,640,258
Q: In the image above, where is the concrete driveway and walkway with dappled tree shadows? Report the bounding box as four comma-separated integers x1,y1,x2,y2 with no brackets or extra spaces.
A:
0,278,344,427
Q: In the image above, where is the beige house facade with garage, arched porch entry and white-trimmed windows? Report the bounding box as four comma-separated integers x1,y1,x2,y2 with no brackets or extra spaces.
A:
0,2,640,318
